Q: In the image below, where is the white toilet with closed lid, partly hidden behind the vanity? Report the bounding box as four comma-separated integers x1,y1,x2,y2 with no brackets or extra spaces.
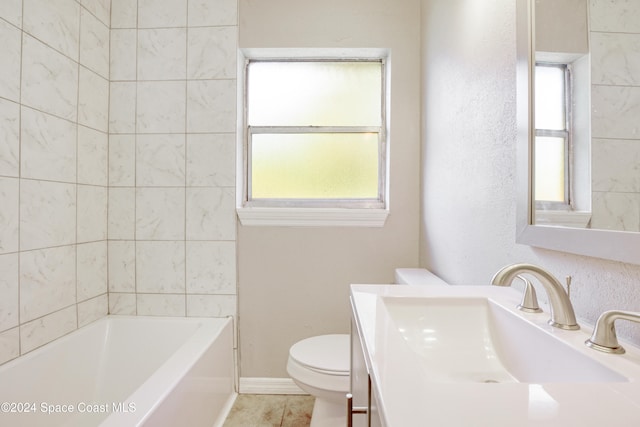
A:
287,268,447,427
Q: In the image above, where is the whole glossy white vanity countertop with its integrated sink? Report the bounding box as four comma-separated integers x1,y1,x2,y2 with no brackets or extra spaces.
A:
350,285,640,427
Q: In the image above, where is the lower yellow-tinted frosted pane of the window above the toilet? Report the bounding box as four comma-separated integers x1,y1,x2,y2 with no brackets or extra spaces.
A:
251,133,378,199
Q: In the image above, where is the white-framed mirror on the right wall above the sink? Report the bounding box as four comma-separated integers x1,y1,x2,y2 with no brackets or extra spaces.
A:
516,0,640,264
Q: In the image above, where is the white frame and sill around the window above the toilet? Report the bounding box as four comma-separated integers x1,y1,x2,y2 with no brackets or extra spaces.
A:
236,49,390,227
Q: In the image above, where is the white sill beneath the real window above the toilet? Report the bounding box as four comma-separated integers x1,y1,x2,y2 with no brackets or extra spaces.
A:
237,208,389,227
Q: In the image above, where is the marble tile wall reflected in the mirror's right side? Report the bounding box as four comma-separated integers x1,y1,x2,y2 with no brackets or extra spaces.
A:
590,0,640,231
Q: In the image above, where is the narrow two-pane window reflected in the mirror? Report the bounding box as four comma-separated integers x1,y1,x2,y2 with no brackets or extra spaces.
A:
534,63,571,209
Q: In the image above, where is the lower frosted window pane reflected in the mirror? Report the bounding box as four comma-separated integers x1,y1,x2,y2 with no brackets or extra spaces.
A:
535,137,565,202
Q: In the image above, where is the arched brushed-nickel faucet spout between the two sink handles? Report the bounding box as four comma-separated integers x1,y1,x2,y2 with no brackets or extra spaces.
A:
491,264,580,330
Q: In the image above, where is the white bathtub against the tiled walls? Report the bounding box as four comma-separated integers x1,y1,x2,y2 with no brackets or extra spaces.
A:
0,316,236,427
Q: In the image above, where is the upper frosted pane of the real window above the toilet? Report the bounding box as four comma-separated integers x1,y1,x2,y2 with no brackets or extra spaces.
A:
247,62,382,126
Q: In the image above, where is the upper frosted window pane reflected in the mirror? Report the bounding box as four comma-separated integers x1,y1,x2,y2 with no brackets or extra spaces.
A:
535,66,566,130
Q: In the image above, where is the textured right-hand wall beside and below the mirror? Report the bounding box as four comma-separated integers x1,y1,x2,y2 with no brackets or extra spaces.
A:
420,0,640,343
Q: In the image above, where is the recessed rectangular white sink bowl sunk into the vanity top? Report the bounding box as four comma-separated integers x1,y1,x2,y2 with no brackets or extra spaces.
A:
380,296,628,384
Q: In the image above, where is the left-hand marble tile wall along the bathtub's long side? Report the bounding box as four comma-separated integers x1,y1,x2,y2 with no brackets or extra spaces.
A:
0,0,110,363
